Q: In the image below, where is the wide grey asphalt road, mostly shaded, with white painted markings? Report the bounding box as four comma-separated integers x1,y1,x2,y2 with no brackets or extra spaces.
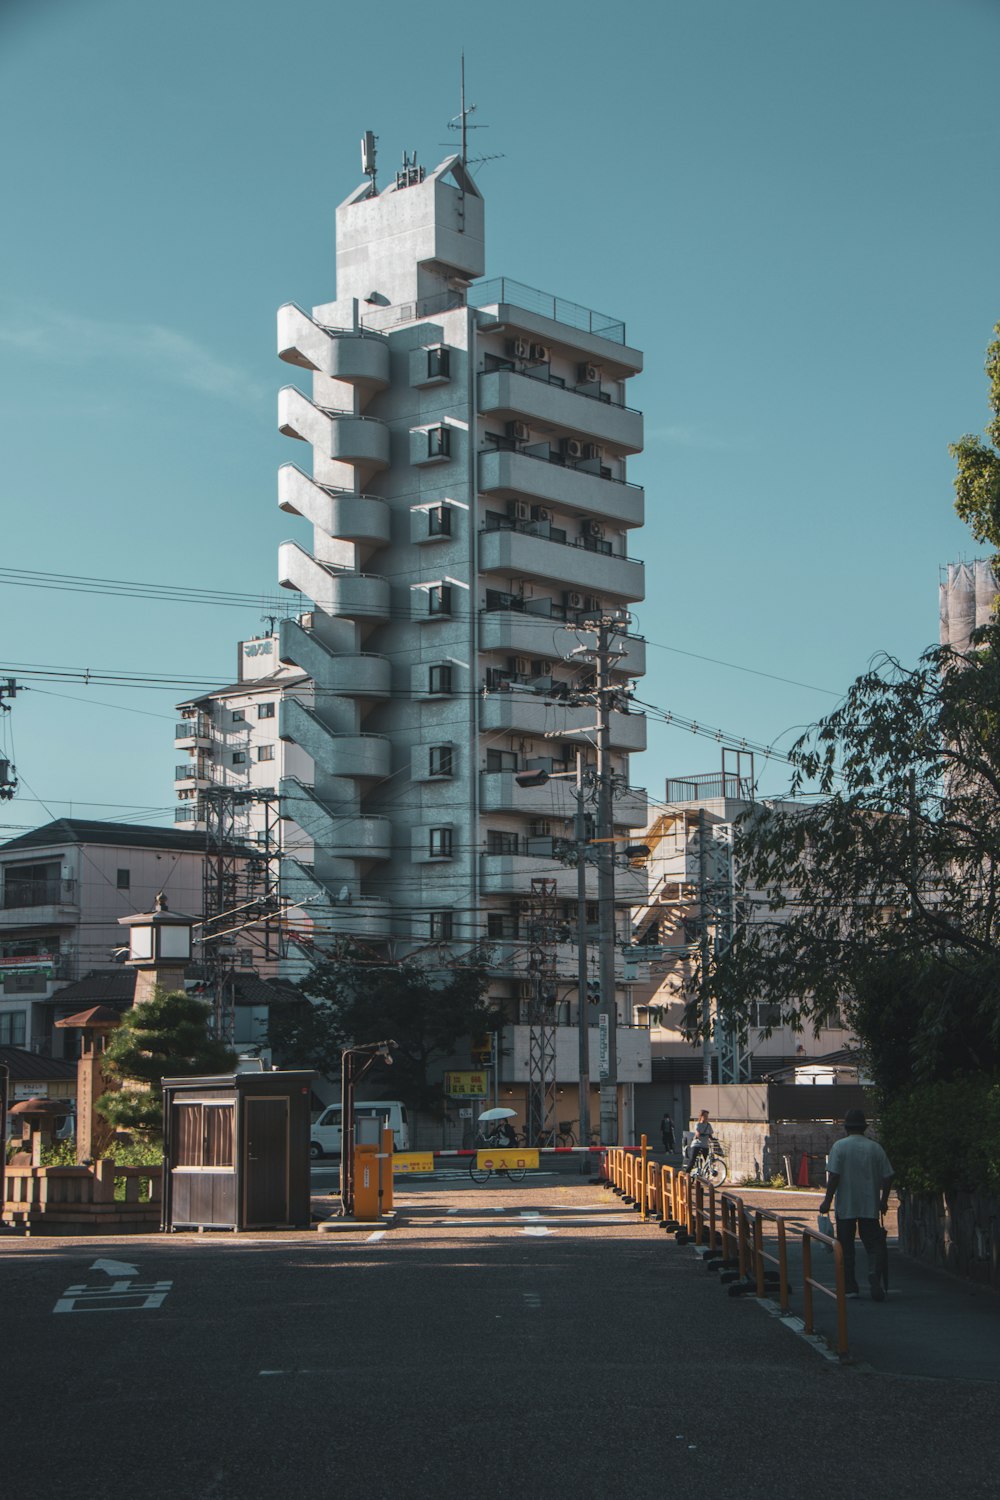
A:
0,1178,999,1500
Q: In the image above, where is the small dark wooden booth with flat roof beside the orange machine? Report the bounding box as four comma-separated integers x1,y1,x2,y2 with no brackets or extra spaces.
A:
163,1073,313,1230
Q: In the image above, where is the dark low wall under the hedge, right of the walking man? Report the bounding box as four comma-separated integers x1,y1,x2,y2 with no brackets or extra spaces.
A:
900,1193,1000,1292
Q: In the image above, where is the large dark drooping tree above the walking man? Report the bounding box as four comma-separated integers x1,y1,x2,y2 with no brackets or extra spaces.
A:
701,624,1000,1088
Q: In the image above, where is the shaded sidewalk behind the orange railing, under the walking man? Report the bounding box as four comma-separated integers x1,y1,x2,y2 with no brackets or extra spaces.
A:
736,1188,1000,1382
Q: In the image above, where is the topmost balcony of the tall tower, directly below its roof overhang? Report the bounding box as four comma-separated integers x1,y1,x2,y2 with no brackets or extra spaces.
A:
478,371,642,455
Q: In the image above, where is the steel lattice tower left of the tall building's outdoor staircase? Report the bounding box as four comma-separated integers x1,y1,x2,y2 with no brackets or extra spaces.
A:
201,788,280,1043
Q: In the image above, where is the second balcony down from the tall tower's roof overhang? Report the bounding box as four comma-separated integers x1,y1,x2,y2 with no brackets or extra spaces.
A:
478,449,645,527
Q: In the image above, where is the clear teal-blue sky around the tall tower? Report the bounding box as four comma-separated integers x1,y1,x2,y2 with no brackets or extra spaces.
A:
0,0,1000,827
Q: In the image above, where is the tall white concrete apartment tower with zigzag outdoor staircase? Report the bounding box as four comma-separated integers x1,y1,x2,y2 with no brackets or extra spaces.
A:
269,146,646,1020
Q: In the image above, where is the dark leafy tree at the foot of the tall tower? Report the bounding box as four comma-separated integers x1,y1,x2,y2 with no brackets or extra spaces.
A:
268,944,498,1115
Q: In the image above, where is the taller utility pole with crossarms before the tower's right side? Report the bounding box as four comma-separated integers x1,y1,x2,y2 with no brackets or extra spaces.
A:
595,617,618,1146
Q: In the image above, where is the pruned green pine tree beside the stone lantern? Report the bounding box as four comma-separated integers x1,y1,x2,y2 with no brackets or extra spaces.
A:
96,990,235,1134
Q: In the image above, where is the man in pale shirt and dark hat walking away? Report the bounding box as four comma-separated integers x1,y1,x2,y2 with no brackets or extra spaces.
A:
820,1110,892,1302
